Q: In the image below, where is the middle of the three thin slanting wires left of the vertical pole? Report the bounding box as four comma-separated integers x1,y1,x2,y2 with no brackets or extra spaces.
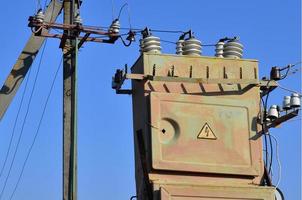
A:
0,40,47,200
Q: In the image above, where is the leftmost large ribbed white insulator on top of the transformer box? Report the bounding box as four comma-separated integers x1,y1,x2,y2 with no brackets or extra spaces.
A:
140,35,161,53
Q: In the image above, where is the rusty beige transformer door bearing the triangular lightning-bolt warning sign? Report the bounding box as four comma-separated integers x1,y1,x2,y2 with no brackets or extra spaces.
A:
150,92,262,177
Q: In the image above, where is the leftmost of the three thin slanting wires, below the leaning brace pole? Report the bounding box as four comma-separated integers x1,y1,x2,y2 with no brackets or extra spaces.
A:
0,68,31,178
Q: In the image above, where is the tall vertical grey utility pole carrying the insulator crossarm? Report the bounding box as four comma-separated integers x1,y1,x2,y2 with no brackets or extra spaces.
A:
61,0,78,200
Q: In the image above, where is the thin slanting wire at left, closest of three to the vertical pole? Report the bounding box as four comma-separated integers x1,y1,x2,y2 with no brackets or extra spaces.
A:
9,59,63,200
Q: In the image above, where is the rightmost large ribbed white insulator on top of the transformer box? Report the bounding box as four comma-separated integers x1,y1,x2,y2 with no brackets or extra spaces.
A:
223,39,243,59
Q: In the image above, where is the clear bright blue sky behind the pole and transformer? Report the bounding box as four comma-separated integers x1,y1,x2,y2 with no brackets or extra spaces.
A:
0,0,301,200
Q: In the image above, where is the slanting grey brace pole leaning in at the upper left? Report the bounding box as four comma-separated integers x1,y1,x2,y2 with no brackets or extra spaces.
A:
0,0,62,119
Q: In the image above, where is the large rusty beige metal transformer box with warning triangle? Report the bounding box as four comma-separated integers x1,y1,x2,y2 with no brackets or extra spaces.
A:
131,53,274,200
